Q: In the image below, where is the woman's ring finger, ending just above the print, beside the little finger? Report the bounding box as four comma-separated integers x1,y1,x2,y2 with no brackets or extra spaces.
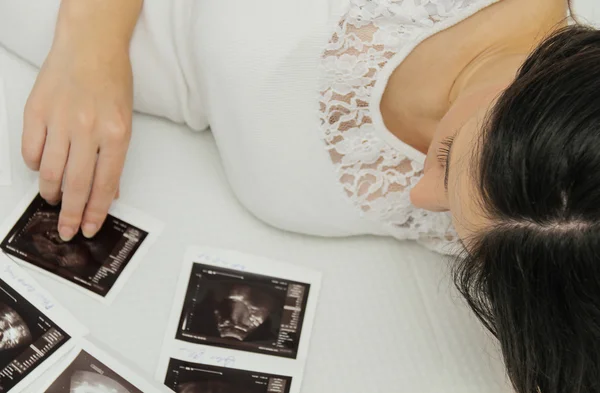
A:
40,129,69,205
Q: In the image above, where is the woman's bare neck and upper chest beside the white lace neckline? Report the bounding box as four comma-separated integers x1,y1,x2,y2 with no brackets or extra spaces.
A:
380,0,566,153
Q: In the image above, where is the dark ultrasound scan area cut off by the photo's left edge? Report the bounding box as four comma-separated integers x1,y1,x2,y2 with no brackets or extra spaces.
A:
0,280,70,393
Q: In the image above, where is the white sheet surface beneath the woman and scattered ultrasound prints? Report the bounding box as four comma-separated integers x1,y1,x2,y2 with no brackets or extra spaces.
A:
0,0,600,393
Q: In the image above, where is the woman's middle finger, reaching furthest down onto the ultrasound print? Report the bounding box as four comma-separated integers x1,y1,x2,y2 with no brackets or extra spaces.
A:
58,137,97,241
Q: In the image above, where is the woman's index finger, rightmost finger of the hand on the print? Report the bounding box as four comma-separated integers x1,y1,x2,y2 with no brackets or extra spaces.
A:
81,146,127,238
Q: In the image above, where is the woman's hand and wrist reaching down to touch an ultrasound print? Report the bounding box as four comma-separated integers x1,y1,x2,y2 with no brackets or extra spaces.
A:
22,0,142,240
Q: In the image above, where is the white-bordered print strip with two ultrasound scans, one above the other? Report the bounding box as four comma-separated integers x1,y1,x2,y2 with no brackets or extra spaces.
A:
157,248,320,393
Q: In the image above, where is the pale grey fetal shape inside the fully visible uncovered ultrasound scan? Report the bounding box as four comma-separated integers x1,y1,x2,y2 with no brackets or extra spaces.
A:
214,284,278,341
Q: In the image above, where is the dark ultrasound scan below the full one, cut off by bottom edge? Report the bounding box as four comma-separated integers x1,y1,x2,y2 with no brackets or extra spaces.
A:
165,359,292,393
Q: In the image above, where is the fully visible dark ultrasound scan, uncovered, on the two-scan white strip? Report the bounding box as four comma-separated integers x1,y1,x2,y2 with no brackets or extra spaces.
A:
176,263,310,358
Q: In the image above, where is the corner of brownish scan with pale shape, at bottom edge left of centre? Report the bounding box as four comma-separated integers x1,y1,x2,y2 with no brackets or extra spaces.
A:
44,351,143,393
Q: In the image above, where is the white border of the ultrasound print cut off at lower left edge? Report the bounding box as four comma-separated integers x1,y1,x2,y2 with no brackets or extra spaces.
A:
0,253,88,393
